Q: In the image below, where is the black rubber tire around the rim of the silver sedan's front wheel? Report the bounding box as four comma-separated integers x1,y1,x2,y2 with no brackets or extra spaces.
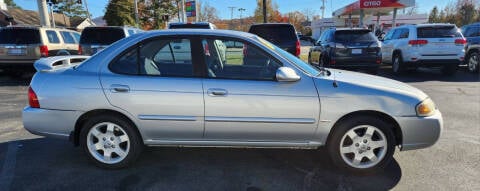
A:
327,116,396,174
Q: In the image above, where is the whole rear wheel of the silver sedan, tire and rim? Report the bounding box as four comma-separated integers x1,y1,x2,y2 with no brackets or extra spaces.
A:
80,115,143,169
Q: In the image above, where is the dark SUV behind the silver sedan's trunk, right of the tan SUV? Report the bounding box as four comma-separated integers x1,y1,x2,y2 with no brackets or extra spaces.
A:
78,26,142,55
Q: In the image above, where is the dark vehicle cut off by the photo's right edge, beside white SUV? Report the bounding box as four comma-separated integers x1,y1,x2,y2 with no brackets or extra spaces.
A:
462,22,480,73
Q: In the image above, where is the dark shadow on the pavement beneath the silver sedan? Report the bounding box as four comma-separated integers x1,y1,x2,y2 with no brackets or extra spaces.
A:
0,138,402,191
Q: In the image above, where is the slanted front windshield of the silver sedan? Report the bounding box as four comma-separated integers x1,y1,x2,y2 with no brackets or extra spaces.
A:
254,36,320,76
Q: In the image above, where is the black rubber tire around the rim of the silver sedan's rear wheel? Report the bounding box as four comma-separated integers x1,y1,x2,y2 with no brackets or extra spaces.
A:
80,114,144,169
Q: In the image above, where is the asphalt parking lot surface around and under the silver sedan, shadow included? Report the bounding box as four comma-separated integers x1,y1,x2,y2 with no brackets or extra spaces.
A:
0,67,480,191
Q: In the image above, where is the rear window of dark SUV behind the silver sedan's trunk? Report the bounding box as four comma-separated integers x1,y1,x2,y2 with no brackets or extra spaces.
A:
80,28,125,45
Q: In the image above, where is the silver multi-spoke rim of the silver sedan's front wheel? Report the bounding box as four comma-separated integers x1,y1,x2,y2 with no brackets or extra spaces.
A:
340,125,388,169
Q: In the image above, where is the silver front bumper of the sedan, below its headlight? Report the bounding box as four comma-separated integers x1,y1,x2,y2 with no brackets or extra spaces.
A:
396,110,443,151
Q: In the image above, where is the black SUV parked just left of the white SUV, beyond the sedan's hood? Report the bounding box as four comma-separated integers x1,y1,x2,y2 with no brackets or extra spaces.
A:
308,28,382,73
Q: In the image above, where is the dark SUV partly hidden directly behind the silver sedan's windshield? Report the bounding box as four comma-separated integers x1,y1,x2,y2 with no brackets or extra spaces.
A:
248,23,300,56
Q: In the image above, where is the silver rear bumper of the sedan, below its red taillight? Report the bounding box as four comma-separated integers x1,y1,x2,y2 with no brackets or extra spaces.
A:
22,106,81,140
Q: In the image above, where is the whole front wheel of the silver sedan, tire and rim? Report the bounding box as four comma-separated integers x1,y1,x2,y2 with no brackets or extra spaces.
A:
327,117,395,174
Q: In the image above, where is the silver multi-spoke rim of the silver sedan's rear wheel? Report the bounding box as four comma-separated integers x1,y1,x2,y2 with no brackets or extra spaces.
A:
87,122,130,164
